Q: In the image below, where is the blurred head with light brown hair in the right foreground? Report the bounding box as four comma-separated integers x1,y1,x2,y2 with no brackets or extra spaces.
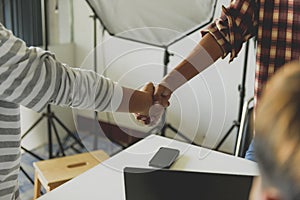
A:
255,62,300,200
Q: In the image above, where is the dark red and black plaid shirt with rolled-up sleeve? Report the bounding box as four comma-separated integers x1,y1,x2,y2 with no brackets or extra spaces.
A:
202,0,300,108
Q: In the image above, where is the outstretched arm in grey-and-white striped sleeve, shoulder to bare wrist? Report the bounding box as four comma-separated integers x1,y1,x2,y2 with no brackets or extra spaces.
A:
0,21,153,114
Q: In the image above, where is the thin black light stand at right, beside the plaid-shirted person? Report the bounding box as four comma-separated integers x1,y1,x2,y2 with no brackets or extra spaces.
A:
215,40,249,152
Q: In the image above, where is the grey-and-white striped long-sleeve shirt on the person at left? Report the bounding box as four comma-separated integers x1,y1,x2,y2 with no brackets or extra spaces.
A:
0,24,122,199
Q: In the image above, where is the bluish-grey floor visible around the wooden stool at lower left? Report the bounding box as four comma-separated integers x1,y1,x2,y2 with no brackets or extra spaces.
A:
19,132,122,200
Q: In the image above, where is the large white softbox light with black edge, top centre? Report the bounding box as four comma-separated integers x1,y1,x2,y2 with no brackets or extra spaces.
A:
87,0,216,47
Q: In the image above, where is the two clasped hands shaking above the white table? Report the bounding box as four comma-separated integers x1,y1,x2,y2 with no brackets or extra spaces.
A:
134,82,172,126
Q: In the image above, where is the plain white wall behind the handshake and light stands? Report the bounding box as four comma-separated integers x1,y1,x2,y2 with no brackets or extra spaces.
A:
70,0,255,152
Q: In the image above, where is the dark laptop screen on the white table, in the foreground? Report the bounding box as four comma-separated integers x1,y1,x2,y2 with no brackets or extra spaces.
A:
124,167,253,200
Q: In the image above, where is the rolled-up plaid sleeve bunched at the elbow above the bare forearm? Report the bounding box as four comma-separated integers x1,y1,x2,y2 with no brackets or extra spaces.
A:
201,0,258,62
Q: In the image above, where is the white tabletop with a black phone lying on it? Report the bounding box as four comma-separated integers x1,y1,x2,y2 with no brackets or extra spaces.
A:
39,135,259,200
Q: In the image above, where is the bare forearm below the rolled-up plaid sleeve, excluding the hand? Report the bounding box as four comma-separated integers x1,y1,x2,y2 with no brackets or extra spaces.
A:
161,34,223,91
